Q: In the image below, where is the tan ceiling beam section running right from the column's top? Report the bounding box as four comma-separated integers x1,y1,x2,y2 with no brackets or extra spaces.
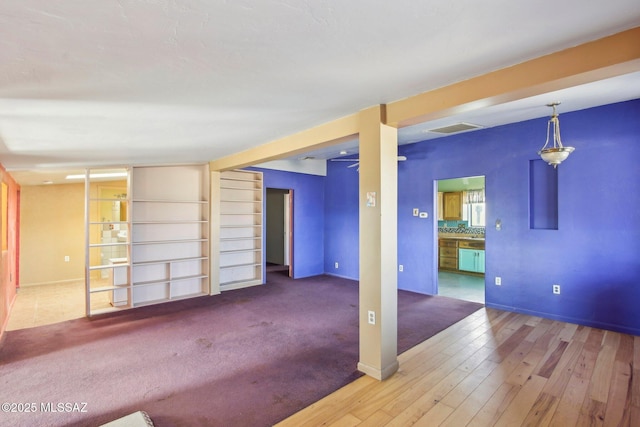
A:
387,27,640,127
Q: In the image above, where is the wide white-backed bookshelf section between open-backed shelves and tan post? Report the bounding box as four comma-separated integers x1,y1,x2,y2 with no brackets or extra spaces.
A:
131,165,209,307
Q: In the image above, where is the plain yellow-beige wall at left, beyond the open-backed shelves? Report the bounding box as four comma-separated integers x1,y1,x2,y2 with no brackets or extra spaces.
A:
20,183,84,286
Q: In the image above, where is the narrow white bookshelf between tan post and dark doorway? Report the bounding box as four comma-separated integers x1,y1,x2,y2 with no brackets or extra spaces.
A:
212,170,263,291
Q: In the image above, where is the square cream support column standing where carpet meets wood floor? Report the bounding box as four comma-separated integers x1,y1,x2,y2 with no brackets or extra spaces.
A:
358,106,398,380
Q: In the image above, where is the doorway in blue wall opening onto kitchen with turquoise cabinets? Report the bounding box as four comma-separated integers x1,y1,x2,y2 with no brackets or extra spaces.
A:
436,176,487,303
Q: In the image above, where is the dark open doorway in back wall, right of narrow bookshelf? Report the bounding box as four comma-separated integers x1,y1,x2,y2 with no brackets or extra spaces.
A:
265,188,293,277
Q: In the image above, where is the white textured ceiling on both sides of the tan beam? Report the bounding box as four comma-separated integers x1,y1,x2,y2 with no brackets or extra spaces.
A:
0,0,640,185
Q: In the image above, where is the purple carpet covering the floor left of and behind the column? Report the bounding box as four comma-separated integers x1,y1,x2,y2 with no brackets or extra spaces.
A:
0,273,482,427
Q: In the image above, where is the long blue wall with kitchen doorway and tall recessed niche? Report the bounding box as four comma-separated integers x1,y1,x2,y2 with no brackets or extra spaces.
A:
324,100,640,335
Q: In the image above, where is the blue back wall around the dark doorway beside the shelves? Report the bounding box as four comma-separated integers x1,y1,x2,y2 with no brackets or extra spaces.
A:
249,168,325,278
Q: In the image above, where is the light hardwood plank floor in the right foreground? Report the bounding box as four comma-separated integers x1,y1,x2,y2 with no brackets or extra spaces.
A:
277,309,640,427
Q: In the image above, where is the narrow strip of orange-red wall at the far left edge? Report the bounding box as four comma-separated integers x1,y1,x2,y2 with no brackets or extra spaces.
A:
0,165,20,338
